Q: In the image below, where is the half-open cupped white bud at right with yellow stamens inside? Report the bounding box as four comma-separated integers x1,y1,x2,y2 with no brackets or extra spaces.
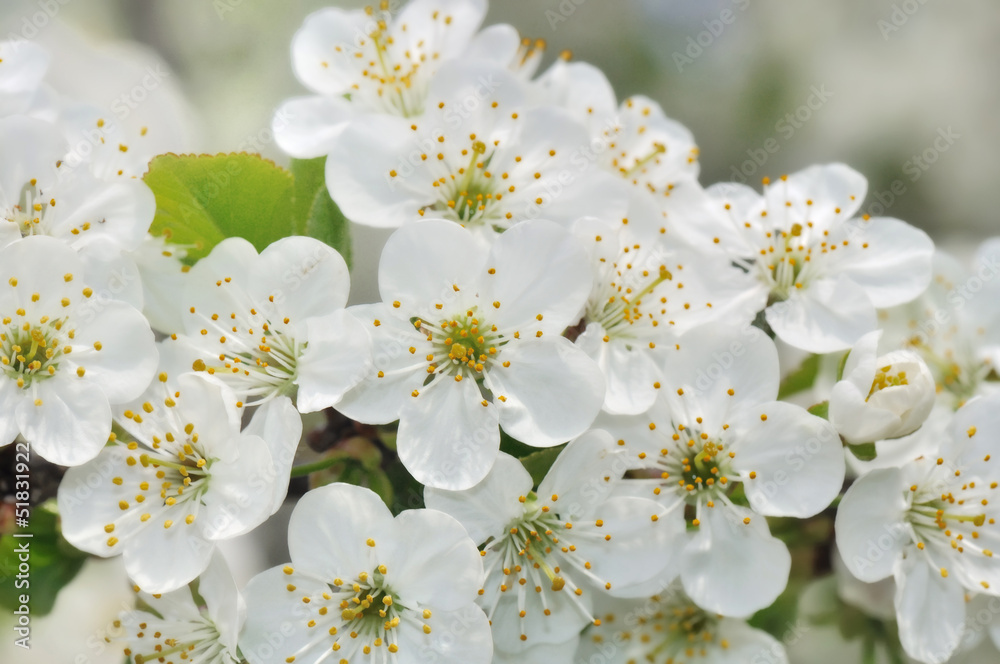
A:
830,330,937,444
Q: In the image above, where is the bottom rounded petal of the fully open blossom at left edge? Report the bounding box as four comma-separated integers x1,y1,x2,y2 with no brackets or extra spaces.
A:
16,375,111,466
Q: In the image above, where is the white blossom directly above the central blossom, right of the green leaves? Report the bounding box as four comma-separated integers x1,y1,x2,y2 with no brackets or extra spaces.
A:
326,63,628,244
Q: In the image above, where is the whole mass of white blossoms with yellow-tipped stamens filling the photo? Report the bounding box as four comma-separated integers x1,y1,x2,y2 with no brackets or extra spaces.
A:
0,0,1000,664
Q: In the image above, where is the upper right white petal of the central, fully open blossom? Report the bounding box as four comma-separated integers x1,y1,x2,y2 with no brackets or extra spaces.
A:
480,221,594,334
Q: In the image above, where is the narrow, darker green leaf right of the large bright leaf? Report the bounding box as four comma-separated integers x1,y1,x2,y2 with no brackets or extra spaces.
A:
291,157,351,266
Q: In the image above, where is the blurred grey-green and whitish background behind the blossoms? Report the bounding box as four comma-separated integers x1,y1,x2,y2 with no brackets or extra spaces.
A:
0,0,1000,664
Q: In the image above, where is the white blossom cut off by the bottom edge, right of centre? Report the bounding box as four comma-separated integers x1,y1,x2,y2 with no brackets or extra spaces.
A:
576,584,788,664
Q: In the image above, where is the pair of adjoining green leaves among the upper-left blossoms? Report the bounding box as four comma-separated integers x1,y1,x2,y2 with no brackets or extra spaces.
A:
144,153,351,264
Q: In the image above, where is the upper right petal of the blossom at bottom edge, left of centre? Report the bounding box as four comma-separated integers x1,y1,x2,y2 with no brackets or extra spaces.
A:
375,509,483,611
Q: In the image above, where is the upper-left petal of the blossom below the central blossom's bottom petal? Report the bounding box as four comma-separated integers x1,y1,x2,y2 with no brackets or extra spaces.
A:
424,452,532,545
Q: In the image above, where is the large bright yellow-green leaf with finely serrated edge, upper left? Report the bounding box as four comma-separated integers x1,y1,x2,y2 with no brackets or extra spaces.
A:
143,153,295,263
